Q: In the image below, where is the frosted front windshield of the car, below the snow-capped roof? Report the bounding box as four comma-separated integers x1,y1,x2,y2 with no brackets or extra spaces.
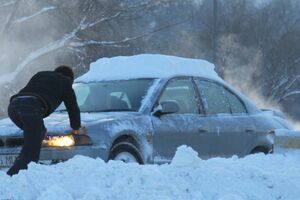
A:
57,79,154,112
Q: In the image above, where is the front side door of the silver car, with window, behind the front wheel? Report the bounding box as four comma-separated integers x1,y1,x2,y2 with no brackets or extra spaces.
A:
152,78,215,163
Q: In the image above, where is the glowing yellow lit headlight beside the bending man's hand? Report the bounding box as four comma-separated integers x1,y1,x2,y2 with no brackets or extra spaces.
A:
43,135,75,147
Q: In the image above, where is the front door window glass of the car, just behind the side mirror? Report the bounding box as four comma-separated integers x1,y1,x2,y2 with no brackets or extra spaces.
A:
159,79,199,114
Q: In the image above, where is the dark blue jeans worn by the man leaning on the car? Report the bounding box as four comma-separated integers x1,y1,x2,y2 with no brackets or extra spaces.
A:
7,96,46,176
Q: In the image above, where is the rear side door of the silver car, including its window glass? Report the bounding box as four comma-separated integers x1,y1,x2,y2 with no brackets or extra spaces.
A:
196,79,255,157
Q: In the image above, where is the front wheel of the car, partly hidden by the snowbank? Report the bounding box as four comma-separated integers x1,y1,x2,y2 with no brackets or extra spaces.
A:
109,142,143,164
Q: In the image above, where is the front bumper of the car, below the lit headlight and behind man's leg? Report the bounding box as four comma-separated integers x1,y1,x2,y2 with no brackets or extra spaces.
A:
0,146,108,161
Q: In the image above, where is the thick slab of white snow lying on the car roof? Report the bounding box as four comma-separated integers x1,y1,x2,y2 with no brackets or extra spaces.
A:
76,54,221,82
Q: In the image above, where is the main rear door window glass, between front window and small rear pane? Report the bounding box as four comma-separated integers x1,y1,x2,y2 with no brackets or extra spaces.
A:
198,81,231,115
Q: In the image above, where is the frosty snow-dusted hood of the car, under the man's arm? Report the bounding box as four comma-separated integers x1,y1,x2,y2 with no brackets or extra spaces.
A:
0,112,141,137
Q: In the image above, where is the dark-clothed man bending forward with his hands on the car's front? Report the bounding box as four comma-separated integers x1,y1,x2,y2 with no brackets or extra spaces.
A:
7,65,81,176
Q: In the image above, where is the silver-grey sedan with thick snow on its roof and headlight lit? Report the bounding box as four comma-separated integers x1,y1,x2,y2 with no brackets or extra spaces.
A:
0,55,292,166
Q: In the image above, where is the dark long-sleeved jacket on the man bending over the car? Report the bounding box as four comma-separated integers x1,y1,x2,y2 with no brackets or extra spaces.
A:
11,71,81,130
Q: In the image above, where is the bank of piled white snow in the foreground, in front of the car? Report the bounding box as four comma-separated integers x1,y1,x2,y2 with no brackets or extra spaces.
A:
0,146,300,200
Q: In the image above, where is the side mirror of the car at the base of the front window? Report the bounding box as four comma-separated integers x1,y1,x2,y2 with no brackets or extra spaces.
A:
153,100,179,117
